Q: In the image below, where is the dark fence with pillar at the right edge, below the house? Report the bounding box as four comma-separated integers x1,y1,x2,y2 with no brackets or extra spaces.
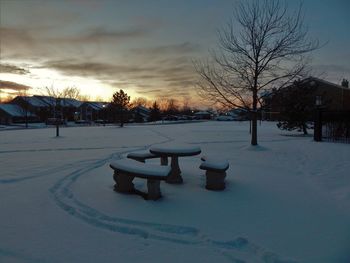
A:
314,110,350,143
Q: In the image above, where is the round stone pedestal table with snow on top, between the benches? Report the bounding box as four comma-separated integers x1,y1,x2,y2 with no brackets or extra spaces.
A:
150,145,201,184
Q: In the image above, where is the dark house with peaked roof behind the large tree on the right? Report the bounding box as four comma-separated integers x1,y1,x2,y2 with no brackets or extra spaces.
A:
262,77,350,120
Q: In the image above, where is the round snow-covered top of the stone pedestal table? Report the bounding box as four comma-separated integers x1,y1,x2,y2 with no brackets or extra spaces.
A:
149,145,201,156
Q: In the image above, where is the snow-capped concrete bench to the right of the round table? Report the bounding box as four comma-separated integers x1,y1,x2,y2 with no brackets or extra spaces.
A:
199,157,229,190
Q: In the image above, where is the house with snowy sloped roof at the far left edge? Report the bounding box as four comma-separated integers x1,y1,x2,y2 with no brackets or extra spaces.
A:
0,104,39,124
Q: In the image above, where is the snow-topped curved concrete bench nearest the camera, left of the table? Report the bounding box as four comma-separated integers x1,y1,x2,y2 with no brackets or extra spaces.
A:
110,159,171,200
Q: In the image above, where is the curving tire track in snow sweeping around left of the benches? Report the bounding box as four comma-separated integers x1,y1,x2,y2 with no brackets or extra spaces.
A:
49,130,295,263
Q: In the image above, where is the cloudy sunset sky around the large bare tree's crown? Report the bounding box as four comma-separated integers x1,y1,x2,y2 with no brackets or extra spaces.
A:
0,0,350,105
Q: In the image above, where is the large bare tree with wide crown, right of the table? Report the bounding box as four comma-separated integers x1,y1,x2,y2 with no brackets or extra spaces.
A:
195,0,319,145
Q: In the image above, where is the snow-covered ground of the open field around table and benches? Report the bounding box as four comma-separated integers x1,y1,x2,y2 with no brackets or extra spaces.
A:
0,121,350,263
